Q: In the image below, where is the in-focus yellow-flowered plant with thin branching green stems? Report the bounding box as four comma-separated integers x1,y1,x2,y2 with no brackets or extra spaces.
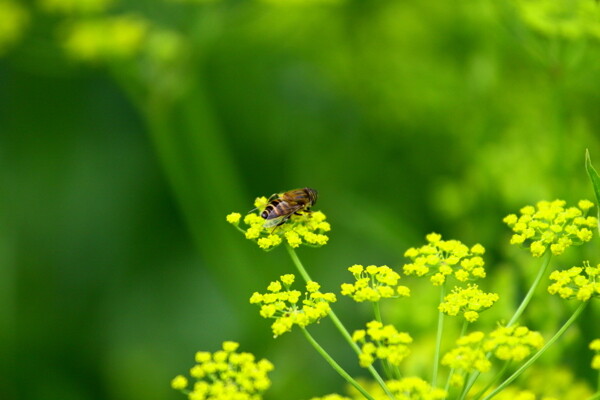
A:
173,156,600,400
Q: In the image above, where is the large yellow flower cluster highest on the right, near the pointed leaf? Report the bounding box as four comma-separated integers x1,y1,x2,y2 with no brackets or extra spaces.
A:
503,200,598,257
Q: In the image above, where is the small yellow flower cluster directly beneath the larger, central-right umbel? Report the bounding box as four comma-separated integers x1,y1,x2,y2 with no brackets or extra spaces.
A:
438,285,498,322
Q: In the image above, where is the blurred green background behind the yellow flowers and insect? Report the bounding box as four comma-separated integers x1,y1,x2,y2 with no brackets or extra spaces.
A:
0,0,600,400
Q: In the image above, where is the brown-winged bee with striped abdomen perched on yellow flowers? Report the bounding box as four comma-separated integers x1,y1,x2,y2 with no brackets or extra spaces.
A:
260,188,318,228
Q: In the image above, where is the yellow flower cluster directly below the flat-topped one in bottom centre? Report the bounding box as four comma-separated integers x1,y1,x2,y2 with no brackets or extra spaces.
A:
352,321,412,368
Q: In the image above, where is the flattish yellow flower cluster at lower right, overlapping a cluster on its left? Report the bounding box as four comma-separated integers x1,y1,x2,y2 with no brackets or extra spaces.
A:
483,325,544,361
